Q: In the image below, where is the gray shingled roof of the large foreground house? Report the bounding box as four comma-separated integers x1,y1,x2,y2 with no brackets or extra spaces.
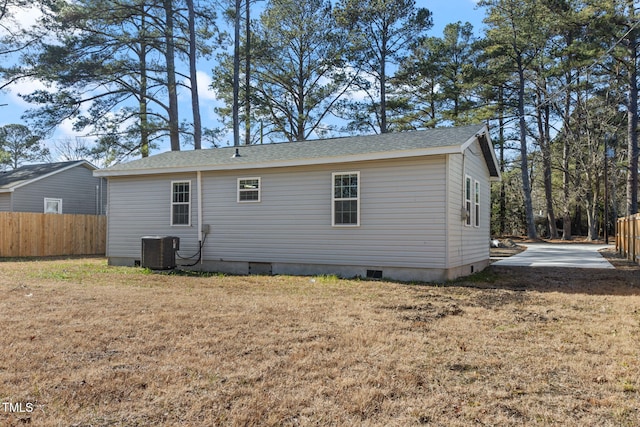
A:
94,125,499,177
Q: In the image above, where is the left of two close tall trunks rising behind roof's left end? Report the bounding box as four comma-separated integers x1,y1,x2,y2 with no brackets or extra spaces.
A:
163,0,180,151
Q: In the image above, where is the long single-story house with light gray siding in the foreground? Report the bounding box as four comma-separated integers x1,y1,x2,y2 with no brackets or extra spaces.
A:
94,125,500,281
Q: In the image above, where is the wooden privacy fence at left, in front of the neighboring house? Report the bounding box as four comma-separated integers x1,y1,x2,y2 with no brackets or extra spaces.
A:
0,212,107,257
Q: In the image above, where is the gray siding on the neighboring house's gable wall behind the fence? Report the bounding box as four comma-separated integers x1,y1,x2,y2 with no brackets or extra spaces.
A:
13,166,106,215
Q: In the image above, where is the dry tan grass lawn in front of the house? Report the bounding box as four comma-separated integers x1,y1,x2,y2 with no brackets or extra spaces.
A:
0,258,640,426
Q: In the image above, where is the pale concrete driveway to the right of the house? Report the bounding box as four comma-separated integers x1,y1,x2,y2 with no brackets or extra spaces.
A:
493,243,614,268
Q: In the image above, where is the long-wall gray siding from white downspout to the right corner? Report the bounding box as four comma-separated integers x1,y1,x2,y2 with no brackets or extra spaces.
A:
203,156,445,268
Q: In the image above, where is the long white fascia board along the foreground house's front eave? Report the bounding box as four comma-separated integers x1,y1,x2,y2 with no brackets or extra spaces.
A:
93,144,461,177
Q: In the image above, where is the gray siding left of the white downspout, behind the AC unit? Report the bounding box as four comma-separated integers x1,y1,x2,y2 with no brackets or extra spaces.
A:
107,174,198,259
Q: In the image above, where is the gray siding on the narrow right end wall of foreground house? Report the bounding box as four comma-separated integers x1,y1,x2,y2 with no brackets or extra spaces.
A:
447,142,491,267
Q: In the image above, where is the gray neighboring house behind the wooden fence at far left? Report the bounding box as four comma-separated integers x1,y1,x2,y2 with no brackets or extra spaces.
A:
0,160,107,215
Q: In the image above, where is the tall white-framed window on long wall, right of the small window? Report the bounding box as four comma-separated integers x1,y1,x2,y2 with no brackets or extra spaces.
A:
331,172,360,227
